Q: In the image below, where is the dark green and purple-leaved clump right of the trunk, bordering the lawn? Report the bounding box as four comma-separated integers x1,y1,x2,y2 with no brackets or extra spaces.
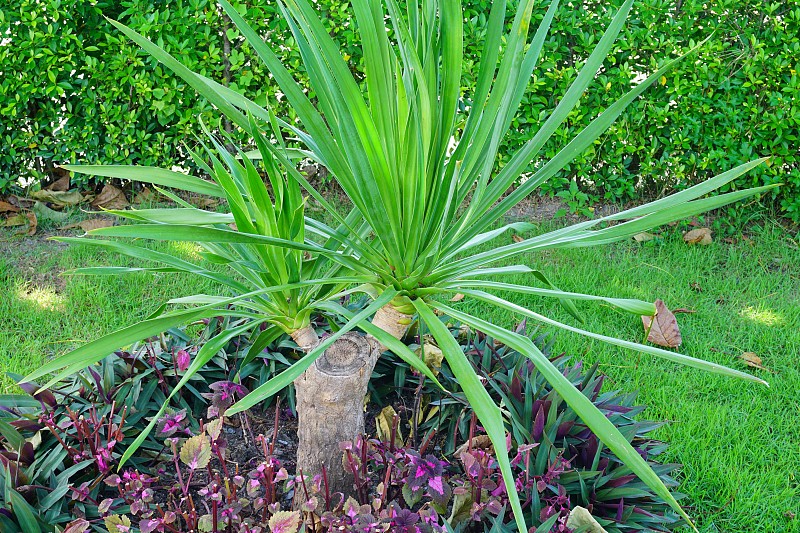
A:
372,322,684,532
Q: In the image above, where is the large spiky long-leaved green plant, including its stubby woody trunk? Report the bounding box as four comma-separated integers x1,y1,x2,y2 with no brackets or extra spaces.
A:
23,0,769,531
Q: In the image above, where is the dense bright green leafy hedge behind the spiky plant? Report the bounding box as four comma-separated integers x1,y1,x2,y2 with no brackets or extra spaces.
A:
0,0,800,220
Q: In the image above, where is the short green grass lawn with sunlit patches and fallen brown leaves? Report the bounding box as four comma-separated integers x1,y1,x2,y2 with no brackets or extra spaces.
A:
0,215,800,533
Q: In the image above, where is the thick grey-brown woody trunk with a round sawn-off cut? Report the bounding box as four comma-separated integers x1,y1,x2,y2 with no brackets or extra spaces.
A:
292,305,411,507
